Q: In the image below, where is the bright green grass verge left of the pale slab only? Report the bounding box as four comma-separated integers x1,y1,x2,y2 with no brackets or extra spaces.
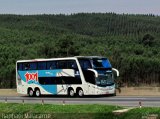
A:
0,103,122,119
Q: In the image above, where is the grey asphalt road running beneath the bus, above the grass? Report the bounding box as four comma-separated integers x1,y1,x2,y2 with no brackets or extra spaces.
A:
0,96,160,107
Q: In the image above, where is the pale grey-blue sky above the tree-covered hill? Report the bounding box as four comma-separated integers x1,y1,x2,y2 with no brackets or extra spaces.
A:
0,0,160,15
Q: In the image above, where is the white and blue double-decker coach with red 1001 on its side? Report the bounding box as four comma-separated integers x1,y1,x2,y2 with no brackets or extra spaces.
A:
16,56,119,97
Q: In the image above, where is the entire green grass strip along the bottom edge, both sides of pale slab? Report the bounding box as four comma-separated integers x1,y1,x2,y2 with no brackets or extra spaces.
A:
0,103,160,119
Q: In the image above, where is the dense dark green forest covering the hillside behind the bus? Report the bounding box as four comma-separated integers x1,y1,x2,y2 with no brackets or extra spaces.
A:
0,13,160,88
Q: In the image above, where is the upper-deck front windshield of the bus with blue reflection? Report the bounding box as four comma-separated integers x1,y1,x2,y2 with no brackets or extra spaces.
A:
92,58,111,68
